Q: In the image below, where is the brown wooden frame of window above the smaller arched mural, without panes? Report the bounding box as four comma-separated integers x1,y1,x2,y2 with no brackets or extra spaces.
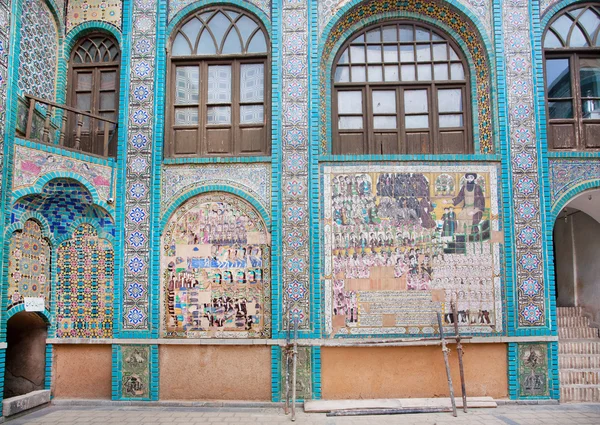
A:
164,5,271,158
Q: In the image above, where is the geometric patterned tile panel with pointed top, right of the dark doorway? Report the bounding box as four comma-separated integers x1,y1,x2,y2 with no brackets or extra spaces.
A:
56,224,115,338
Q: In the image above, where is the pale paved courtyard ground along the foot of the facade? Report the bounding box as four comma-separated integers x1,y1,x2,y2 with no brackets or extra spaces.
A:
6,404,600,425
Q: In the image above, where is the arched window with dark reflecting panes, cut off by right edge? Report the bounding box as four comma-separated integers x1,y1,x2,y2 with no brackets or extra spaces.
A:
543,4,600,150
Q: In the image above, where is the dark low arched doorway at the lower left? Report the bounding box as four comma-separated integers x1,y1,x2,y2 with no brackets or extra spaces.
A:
4,311,48,399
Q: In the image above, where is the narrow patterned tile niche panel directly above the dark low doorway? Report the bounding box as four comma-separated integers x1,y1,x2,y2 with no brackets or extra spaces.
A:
8,220,52,309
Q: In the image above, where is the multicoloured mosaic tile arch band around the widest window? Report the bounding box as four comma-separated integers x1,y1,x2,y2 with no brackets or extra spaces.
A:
320,0,496,154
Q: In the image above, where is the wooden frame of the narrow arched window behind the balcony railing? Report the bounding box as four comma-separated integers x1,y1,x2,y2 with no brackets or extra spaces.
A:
65,32,121,157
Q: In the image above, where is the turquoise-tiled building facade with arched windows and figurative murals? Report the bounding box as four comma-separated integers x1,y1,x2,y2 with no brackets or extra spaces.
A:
0,0,600,410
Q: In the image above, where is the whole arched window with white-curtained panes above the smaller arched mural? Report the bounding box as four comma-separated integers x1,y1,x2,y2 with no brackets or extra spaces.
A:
165,7,270,157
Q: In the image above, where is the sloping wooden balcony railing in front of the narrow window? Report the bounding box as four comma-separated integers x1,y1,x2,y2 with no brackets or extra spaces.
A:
25,95,118,158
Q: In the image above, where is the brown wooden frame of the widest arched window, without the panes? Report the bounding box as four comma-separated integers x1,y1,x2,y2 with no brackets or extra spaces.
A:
331,20,474,155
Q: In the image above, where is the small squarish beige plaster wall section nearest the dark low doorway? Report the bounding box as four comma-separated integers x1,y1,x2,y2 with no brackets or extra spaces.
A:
52,345,112,399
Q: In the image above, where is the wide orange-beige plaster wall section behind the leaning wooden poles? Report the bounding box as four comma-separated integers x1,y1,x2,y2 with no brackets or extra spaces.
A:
321,344,508,399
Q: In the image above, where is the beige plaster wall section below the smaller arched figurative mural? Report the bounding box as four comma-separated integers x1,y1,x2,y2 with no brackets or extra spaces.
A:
159,345,271,401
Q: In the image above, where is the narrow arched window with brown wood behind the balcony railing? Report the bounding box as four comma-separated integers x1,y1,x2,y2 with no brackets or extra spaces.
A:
66,33,121,156
